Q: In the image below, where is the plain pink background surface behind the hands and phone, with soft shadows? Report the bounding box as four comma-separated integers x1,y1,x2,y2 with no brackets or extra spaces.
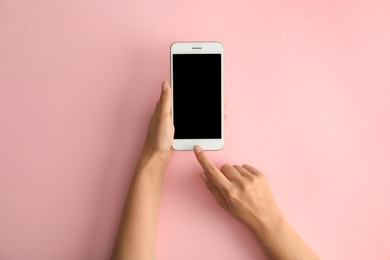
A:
0,0,390,260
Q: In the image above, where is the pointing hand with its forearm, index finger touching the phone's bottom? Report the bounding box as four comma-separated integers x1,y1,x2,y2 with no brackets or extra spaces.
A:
194,146,319,259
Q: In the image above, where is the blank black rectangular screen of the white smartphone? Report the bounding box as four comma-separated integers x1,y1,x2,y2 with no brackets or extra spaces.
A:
172,54,222,139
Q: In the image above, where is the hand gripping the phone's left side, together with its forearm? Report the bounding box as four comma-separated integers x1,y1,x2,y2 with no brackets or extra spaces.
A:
111,81,174,260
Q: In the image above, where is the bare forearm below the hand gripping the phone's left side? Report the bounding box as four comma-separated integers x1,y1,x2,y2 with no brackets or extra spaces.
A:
113,155,166,259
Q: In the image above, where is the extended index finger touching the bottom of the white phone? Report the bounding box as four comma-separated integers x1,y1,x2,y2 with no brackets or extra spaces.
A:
194,145,230,193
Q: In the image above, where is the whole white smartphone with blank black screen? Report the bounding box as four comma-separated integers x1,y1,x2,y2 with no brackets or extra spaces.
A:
171,42,224,150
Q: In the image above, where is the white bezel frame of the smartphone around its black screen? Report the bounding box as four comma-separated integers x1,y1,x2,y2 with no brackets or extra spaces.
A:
170,42,224,150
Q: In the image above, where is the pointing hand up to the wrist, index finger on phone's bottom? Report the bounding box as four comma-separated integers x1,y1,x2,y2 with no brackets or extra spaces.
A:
194,146,283,229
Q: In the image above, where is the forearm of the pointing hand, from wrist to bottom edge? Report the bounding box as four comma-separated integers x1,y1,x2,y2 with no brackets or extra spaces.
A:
251,214,319,260
